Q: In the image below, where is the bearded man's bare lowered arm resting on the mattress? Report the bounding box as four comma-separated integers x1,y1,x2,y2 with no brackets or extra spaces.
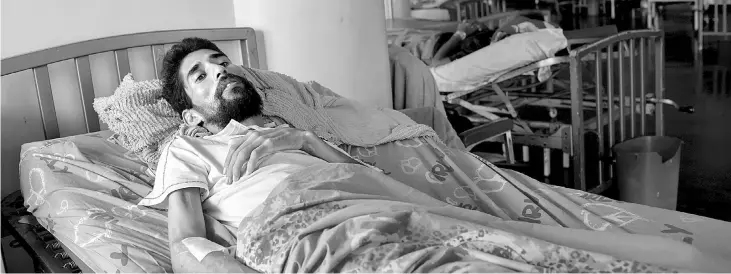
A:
168,187,256,273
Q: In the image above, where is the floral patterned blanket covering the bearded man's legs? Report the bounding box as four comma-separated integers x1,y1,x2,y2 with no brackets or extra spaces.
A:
236,139,731,273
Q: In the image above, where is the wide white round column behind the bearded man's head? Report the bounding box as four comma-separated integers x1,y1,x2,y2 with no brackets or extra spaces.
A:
233,0,393,108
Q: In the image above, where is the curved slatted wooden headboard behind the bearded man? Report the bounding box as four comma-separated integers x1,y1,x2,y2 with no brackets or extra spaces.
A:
0,28,261,197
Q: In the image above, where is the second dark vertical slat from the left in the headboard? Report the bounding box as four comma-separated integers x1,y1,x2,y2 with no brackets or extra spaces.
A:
76,56,100,132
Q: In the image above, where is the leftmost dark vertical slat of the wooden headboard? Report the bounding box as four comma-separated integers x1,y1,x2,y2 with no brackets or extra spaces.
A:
32,66,61,139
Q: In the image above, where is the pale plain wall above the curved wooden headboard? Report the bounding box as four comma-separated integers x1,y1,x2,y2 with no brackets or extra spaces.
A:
0,0,235,58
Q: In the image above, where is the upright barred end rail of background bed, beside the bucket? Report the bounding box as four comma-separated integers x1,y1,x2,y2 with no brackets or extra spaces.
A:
570,30,665,193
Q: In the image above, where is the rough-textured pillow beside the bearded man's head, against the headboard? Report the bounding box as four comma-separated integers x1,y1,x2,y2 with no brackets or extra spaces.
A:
94,74,183,169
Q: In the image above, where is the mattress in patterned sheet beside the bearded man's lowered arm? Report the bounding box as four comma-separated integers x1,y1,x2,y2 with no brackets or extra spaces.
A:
20,131,235,273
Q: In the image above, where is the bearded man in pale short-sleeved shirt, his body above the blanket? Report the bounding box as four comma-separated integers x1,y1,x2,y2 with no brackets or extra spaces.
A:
140,39,388,272
